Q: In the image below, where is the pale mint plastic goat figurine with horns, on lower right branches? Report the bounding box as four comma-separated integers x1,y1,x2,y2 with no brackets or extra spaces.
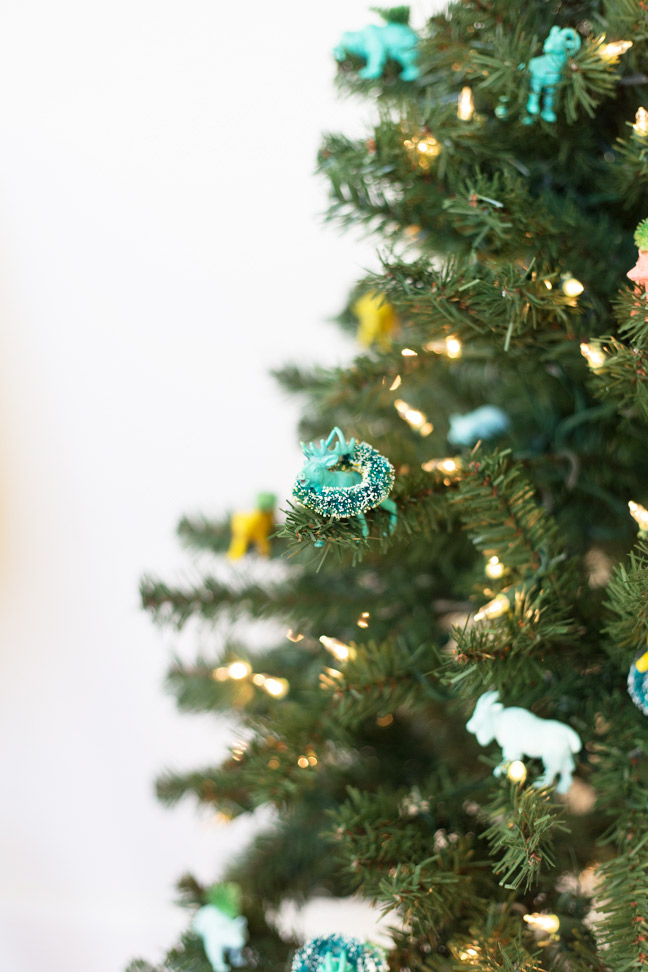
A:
466,692,583,793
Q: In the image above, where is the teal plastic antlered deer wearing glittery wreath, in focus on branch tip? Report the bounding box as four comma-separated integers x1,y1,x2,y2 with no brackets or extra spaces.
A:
292,426,398,546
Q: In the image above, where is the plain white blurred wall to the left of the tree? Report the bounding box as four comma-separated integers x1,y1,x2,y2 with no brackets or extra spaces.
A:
0,0,436,972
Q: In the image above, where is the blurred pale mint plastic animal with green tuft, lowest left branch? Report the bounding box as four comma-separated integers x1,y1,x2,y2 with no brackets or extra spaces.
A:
191,884,247,972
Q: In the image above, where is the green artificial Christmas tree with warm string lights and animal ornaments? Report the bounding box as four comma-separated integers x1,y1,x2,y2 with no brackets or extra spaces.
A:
132,0,648,972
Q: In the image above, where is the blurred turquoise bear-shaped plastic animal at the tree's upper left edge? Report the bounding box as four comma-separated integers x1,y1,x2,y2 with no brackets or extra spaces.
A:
333,11,419,81
